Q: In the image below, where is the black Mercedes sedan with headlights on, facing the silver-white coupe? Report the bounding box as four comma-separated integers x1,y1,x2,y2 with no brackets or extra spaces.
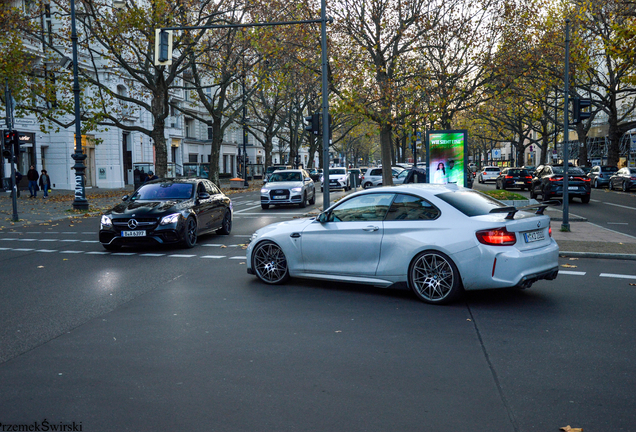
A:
99,178,233,251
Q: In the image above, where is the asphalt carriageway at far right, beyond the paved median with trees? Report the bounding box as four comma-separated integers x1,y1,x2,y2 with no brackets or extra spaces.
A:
473,182,636,237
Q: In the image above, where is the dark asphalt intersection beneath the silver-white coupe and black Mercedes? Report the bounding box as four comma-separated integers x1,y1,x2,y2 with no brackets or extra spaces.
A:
0,186,636,432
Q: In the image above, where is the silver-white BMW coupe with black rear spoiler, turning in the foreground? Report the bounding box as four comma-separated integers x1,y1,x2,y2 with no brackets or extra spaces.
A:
246,184,559,304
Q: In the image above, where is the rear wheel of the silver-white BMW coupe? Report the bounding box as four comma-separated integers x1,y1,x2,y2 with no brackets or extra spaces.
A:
408,251,462,304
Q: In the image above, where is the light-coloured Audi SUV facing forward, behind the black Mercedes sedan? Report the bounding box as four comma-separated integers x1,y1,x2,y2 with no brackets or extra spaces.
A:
261,169,316,210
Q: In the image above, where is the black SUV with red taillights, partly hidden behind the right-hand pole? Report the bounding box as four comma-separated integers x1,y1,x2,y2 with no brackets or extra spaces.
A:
530,165,591,203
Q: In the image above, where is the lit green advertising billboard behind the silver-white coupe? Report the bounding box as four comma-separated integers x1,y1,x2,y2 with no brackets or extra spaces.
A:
426,130,468,186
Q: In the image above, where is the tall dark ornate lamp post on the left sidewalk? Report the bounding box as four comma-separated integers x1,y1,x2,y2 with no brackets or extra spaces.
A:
71,0,88,210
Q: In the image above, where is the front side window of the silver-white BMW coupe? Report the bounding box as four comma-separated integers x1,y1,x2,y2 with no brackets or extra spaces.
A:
329,193,394,222
